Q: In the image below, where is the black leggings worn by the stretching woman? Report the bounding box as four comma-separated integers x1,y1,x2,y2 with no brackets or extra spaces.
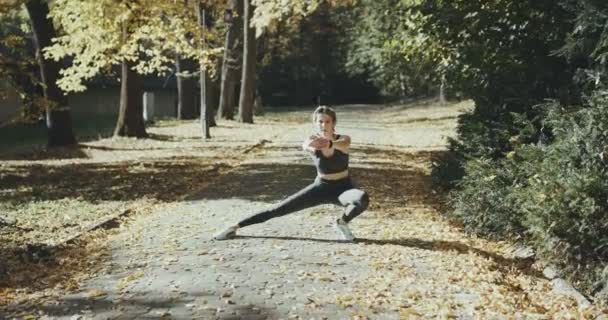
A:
238,177,369,227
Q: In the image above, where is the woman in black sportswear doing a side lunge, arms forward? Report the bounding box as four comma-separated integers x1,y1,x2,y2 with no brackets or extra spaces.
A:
213,106,369,241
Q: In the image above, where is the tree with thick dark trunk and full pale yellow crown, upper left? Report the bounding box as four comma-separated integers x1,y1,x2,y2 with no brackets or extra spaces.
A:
45,0,220,137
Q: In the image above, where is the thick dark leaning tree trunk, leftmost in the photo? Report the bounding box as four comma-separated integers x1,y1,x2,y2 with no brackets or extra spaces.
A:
25,0,76,147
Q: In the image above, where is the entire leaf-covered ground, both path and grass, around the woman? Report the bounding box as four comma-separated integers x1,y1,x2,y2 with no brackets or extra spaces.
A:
0,101,602,319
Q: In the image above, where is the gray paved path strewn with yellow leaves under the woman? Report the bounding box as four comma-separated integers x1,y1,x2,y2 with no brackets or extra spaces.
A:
15,104,600,319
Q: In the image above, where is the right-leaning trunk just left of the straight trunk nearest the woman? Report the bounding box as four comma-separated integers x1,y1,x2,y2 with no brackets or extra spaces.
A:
217,0,243,119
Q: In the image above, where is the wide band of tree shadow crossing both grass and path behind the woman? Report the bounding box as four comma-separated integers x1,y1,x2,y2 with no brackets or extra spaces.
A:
0,147,437,210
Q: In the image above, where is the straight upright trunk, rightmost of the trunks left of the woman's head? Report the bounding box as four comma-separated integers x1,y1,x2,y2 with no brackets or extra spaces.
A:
239,0,257,123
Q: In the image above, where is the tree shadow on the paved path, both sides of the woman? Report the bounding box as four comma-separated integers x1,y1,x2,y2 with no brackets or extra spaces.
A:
186,148,439,210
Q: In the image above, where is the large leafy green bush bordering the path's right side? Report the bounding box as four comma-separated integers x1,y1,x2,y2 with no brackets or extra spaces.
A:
444,94,608,295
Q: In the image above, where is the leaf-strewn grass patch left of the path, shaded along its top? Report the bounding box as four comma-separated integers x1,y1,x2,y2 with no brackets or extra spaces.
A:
0,159,223,249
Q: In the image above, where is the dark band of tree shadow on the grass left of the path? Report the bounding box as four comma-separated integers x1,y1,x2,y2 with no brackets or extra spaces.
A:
0,157,227,205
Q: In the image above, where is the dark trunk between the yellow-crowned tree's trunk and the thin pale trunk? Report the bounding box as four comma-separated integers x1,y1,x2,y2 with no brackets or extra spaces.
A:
175,57,197,120
